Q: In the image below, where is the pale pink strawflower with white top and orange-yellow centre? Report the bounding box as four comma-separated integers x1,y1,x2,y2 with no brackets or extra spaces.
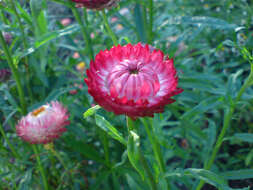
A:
16,101,69,144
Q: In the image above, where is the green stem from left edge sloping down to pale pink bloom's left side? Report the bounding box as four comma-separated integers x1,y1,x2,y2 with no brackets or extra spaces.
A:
0,32,27,115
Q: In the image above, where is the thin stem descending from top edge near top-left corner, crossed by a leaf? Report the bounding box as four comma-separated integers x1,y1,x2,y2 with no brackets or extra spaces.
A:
10,0,33,101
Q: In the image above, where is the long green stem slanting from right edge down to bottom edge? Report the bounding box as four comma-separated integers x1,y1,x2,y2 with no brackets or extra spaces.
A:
196,63,253,190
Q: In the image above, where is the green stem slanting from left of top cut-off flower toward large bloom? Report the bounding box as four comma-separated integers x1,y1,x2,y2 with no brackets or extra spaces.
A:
72,7,94,59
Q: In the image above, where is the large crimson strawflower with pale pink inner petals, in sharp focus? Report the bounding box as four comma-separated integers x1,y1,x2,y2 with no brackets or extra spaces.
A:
85,43,183,119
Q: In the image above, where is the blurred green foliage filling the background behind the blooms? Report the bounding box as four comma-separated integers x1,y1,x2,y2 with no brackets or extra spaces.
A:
0,0,253,190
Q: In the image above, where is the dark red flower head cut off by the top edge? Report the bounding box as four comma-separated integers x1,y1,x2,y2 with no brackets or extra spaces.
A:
72,0,119,10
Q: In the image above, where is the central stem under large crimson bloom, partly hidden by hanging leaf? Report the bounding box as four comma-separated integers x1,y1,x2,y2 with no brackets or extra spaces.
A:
126,116,157,190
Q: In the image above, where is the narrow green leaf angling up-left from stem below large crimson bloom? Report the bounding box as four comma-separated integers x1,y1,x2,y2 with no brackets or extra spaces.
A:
95,114,127,145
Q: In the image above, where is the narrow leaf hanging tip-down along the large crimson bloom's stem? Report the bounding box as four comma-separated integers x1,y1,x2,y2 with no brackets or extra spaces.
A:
127,131,145,179
